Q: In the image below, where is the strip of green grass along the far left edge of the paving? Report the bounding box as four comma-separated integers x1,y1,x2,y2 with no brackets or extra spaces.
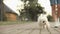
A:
0,21,32,25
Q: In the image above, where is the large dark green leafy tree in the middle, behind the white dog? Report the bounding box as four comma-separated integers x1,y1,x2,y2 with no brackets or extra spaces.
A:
22,0,43,21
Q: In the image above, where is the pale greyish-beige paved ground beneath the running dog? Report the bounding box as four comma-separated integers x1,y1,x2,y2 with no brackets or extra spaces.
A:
0,22,60,34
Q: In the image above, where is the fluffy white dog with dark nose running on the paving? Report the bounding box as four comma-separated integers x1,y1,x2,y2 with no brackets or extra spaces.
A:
38,14,50,28
